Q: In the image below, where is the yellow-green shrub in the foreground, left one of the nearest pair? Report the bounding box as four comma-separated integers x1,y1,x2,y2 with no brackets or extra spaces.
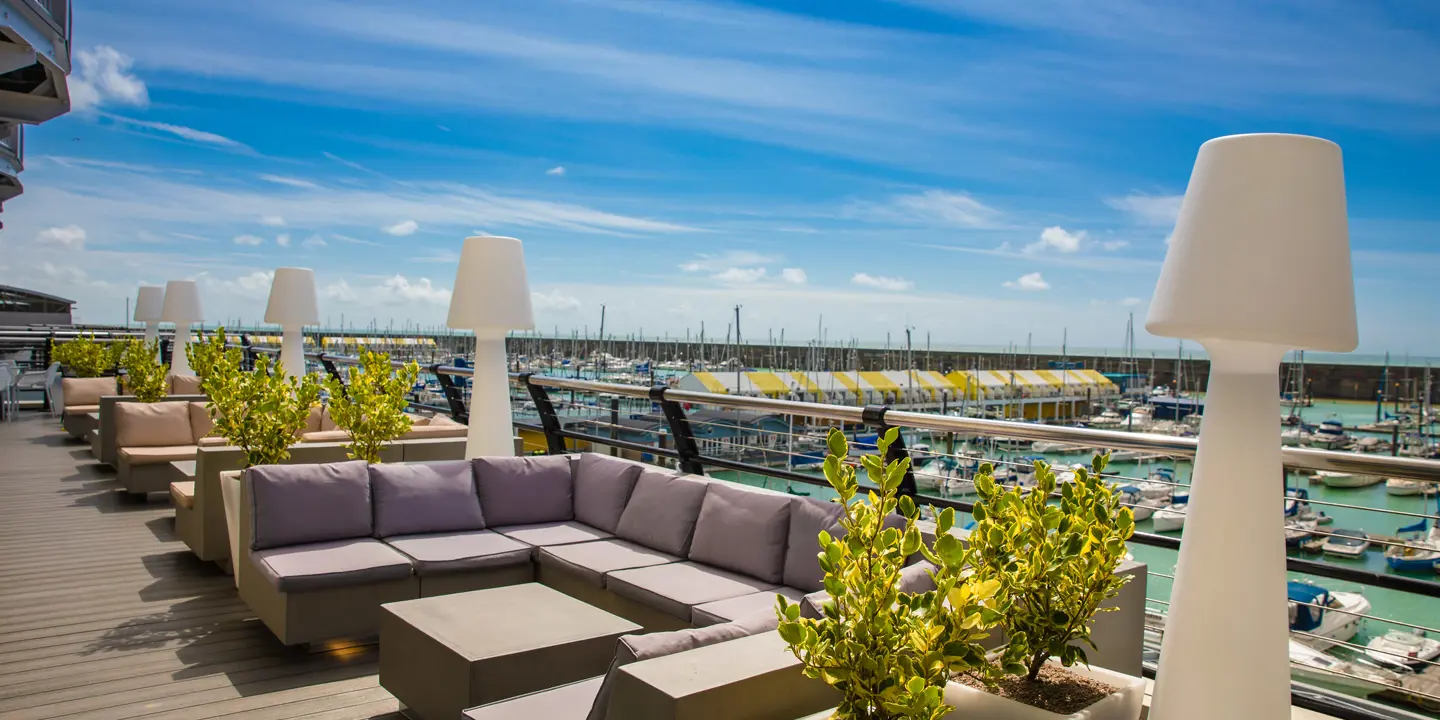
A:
776,429,999,720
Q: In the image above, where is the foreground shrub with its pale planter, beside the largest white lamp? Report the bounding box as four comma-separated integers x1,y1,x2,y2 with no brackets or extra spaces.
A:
946,455,1145,720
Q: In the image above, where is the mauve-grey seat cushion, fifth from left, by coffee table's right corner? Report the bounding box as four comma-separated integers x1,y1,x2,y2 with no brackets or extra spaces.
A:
605,562,776,622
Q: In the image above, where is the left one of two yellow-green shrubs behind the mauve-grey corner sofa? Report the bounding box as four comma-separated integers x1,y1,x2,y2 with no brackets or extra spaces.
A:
202,349,320,468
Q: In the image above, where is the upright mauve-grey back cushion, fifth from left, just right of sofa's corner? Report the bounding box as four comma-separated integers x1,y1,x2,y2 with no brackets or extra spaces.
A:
615,469,708,557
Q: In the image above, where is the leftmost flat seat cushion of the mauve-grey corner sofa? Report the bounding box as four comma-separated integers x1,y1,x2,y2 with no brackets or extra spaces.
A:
251,537,413,592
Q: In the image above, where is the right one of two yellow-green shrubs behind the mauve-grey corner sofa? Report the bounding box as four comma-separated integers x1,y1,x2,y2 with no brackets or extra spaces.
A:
325,350,420,462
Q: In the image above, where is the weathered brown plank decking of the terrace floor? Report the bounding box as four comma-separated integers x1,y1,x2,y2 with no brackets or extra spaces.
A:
0,413,400,720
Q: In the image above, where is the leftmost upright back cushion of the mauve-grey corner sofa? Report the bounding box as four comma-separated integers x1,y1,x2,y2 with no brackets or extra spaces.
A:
246,459,373,550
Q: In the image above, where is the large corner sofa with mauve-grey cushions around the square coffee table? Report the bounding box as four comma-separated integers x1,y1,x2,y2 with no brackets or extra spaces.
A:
236,454,875,644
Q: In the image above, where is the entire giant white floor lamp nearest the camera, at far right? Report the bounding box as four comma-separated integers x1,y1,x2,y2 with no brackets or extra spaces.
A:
1145,134,1358,720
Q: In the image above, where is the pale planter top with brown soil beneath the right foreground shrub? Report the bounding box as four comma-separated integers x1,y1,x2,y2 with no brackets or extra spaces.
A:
945,661,1145,720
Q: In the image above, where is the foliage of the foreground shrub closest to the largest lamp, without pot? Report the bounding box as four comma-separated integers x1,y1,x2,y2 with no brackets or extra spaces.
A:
969,455,1135,681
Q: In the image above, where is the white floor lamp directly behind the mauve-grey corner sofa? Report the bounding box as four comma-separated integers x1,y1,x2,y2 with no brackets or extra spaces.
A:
445,235,534,458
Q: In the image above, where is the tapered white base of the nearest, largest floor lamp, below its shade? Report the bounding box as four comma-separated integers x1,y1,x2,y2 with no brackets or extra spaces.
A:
1151,341,1290,720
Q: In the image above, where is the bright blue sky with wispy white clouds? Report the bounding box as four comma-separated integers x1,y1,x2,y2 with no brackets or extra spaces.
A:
0,0,1440,356
